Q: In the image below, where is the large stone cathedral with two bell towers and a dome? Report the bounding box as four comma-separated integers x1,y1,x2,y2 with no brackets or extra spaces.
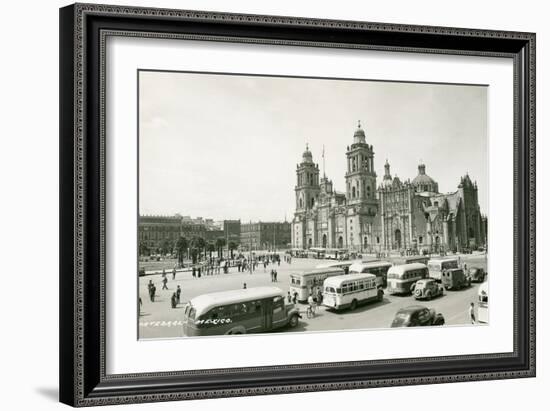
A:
292,123,487,253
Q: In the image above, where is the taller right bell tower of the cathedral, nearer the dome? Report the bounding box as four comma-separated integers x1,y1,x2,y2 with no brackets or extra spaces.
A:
346,122,377,212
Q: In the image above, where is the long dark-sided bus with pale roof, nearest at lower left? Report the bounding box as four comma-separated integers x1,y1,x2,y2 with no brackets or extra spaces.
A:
183,287,300,337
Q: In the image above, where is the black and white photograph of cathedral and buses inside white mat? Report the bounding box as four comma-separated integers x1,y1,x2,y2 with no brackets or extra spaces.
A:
136,69,490,339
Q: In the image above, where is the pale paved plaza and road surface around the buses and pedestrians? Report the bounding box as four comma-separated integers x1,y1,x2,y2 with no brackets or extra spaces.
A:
139,255,486,338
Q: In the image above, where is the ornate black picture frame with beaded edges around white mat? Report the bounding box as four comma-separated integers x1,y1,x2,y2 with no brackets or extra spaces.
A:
60,4,535,406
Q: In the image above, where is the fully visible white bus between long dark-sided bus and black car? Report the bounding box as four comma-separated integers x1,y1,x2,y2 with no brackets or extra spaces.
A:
323,274,384,310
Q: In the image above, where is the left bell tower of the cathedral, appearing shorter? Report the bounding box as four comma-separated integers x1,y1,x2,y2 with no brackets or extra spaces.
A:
294,144,321,213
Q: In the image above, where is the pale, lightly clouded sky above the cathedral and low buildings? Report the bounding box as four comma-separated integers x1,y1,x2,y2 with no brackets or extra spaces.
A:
139,71,488,222
